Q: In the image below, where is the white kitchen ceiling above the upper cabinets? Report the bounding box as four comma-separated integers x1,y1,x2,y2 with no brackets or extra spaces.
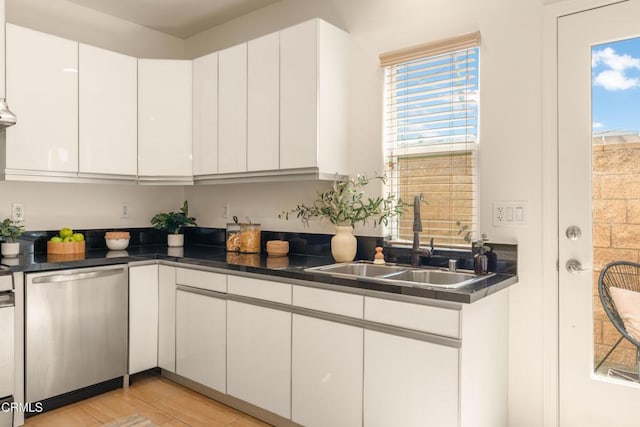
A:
69,0,278,39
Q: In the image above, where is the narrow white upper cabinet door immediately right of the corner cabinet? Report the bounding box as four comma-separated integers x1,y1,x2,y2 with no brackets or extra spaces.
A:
193,52,218,175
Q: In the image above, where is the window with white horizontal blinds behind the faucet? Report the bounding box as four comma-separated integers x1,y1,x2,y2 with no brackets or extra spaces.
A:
380,33,479,246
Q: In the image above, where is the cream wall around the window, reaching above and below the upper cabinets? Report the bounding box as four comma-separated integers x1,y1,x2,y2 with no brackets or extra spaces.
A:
185,0,543,427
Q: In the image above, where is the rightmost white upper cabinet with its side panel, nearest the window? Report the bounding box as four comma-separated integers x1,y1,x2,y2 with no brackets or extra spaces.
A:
280,19,348,174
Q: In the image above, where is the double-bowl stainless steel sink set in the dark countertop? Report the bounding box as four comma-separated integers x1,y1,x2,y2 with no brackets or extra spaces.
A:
306,262,493,288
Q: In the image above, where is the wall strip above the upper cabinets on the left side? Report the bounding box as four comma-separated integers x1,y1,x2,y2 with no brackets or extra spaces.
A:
6,0,184,58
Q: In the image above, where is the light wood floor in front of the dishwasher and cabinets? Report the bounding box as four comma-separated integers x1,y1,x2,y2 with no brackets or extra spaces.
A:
25,375,269,427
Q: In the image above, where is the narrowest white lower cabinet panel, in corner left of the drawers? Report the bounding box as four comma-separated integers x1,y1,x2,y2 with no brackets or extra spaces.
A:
158,265,176,372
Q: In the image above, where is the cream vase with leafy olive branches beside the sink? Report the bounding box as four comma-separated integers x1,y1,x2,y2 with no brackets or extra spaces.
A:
278,175,408,262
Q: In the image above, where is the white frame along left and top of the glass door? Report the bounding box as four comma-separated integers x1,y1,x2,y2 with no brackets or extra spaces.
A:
542,0,626,427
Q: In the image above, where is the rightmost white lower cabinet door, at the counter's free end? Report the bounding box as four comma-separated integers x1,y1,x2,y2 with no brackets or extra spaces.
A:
364,330,458,427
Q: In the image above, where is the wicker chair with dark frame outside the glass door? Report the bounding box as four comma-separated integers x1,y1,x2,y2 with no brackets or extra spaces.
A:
596,261,640,382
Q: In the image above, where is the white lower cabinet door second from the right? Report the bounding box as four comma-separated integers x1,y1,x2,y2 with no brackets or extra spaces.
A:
291,314,364,427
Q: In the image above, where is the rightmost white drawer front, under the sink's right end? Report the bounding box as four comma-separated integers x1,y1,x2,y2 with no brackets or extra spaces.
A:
364,297,460,338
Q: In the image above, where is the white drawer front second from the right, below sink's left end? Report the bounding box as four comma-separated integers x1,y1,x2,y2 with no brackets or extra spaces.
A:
293,286,364,319
